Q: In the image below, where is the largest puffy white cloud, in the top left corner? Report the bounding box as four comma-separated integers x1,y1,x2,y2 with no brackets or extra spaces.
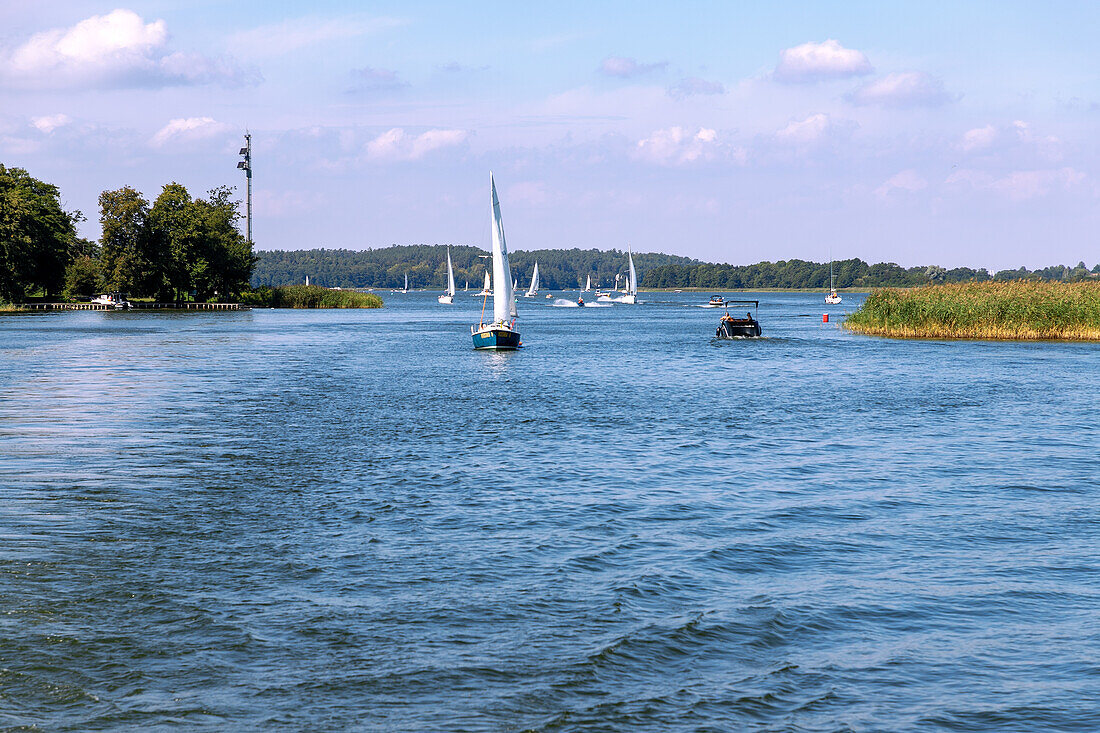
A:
0,9,257,89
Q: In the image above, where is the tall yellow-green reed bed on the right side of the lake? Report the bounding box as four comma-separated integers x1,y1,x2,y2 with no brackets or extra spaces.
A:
845,281,1100,341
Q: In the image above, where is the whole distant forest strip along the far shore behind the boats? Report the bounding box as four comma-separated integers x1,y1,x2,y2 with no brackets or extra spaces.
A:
252,244,1100,289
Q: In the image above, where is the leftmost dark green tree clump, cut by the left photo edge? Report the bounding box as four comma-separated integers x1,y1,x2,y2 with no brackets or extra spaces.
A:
0,164,80,300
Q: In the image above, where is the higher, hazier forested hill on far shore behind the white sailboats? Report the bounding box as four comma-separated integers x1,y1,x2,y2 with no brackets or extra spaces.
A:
252,244,699,289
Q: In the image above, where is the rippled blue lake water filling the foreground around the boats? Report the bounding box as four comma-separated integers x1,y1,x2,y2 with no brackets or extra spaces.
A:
0,293,1100,732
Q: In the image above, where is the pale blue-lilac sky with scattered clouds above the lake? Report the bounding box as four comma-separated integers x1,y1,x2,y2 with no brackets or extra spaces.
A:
0,0,1100,270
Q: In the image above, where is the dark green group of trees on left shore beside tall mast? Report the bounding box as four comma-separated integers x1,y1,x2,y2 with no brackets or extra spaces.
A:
0,164,255,302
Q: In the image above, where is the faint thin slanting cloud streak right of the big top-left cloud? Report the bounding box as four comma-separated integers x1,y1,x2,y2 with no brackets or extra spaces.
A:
230,14,405,57
